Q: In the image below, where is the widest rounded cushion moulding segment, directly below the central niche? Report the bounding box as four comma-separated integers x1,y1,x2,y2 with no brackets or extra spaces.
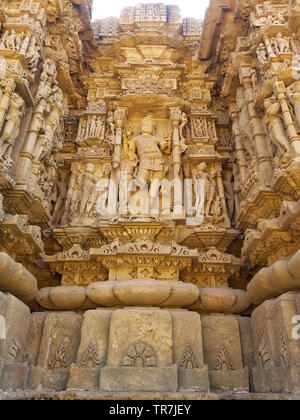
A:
114,280,171,306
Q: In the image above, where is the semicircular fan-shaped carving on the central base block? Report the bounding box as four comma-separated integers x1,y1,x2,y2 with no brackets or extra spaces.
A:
121,342,157,367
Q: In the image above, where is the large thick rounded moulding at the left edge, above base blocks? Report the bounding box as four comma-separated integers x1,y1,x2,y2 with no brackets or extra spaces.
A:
0,252,38,302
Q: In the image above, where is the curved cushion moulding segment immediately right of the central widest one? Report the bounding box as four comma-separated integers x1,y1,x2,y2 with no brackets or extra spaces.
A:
161,282,199,308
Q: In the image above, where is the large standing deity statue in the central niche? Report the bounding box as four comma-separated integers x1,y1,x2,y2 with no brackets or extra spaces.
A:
128,116,171,184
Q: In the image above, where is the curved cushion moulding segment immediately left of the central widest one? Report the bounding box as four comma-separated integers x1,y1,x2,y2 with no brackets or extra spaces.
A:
86,281,121,307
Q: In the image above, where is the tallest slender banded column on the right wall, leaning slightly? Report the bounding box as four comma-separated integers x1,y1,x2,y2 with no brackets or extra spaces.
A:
240,65,273,186
